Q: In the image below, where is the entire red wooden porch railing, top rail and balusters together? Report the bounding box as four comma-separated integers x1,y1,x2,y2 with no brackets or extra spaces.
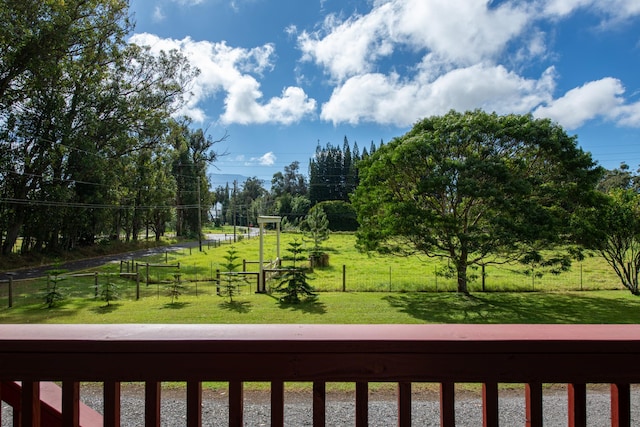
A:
0,325,640,426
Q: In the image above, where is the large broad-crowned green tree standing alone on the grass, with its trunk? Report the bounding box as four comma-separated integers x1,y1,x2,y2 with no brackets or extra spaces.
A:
353,111,601,293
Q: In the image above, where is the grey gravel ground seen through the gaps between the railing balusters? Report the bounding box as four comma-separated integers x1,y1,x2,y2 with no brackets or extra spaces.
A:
2,387,640,427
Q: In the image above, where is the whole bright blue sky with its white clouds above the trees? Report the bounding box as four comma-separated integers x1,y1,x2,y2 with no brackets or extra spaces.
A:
130,0,640,186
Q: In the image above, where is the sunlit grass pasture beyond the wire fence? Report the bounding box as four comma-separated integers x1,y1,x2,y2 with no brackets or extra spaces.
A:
82,232,621,295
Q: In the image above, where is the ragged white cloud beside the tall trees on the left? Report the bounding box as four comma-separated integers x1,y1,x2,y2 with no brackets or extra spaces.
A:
130,33,316,125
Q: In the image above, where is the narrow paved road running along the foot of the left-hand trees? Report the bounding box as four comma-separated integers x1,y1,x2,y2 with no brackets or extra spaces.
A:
0,232,258,280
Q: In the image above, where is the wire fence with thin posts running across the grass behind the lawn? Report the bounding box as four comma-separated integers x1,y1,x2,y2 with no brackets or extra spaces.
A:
0,262,622,307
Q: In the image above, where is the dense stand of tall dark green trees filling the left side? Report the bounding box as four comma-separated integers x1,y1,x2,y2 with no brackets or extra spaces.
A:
0,0,221,254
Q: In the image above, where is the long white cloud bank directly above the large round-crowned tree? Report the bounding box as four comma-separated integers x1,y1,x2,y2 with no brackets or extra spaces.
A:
321,64,554,127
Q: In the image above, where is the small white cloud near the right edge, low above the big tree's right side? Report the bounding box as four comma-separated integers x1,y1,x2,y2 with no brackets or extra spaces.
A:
534,77,632,129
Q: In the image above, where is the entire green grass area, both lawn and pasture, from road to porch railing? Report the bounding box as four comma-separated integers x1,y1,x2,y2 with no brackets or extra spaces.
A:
0,232,640,323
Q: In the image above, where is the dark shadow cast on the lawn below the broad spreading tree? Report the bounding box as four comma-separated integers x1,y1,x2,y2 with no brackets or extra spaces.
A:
384,292,640,324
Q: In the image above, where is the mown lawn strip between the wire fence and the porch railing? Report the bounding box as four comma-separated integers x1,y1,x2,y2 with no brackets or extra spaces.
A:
0,291,640,324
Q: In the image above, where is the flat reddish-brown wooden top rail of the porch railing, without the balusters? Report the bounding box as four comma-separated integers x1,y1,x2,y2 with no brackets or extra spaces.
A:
0,325,640,384
